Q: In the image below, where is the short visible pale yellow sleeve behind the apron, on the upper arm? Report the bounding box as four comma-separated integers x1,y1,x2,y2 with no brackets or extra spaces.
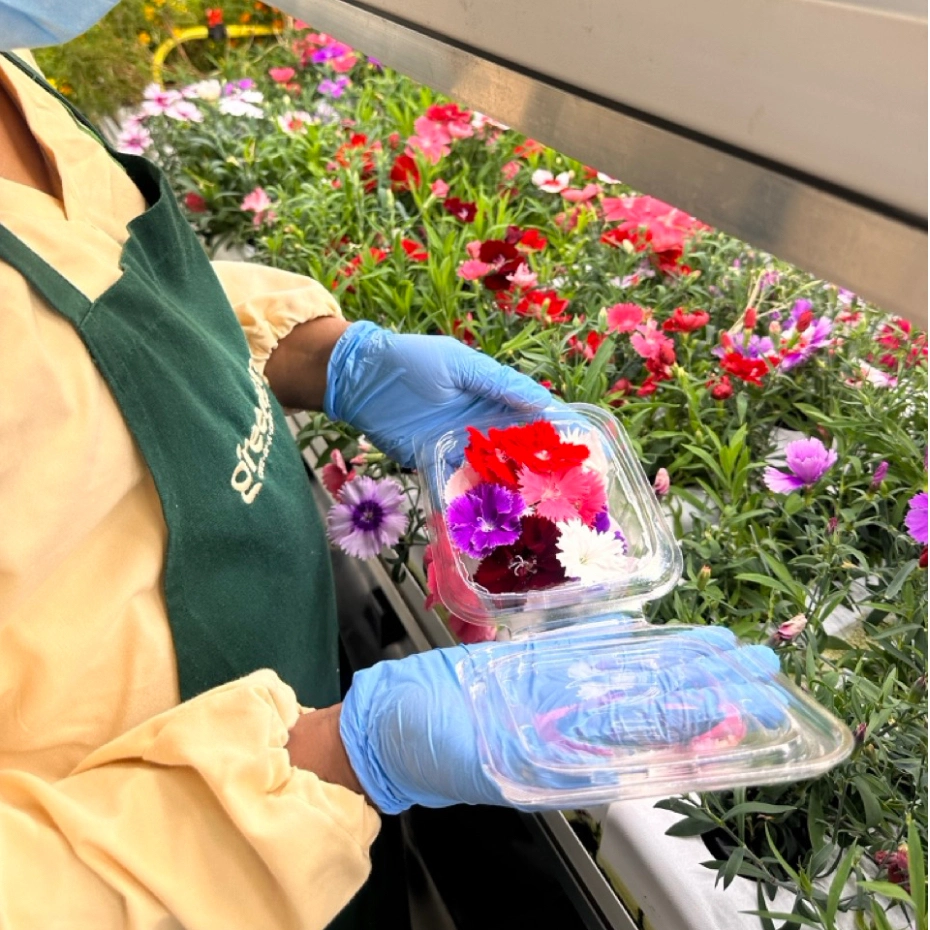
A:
213,261,342,370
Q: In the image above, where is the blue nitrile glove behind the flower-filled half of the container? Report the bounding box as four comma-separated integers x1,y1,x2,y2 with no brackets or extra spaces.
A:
323,322,552,467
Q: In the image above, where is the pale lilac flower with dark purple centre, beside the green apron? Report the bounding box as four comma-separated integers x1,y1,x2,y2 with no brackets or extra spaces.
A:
327,476,407,559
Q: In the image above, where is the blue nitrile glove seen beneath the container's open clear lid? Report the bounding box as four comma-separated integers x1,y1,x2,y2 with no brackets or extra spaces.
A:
340,628,786,814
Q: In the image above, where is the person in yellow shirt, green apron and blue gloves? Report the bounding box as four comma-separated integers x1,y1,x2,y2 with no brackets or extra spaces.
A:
0,9,777,930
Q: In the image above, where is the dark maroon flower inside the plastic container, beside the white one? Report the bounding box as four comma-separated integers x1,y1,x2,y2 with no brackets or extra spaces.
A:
474,516,565,594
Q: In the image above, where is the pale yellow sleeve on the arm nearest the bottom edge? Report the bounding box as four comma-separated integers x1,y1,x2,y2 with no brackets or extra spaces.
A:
0,670,380,930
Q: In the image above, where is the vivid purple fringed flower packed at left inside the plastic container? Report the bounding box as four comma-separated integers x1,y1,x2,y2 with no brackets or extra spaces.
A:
446,481,526,559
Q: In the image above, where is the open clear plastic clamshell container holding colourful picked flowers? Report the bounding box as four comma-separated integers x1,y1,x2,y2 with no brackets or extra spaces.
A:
417,404,853,807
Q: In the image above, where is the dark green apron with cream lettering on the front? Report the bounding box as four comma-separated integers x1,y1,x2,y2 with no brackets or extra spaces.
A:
0,56,339,707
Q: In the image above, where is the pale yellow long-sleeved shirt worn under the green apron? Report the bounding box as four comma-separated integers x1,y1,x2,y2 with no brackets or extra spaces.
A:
0,59,379,930
